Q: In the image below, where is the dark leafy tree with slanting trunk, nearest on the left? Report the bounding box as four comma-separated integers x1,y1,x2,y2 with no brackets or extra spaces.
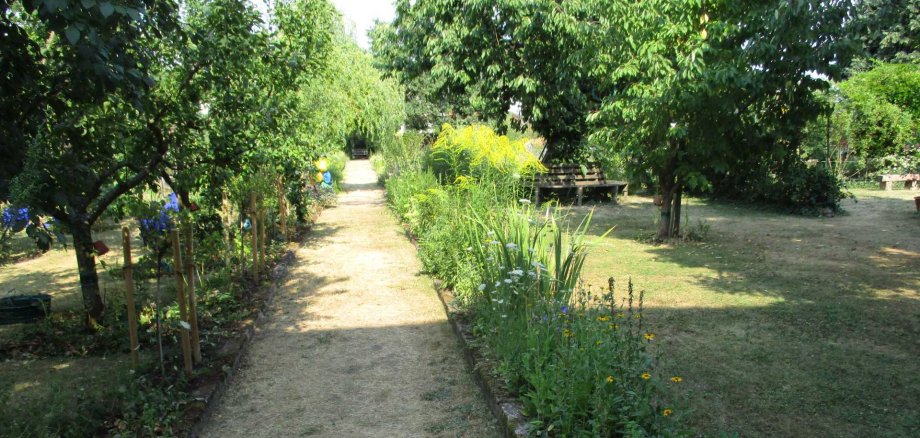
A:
0,0,178,321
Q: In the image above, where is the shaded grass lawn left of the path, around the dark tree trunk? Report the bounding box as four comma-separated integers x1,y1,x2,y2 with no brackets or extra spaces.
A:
0,226,174,437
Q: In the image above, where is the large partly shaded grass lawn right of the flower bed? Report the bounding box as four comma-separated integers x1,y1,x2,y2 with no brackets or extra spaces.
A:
572,190,920,437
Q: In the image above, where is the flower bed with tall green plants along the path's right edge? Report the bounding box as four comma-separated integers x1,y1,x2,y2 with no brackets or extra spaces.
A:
376,125,688,436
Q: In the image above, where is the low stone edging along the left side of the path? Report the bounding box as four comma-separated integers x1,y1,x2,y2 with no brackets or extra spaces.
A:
186,246,298,438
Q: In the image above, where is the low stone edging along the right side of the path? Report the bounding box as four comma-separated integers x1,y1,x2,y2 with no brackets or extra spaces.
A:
403,226,530,438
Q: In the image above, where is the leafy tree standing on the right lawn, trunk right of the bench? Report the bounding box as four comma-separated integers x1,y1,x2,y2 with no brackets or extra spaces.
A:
589,0,852,239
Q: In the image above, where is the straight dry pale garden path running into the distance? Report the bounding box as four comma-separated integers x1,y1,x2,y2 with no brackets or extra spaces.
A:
202,160,497,438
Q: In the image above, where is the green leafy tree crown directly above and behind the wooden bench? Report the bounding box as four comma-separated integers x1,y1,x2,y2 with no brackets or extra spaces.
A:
384,0,603,160
